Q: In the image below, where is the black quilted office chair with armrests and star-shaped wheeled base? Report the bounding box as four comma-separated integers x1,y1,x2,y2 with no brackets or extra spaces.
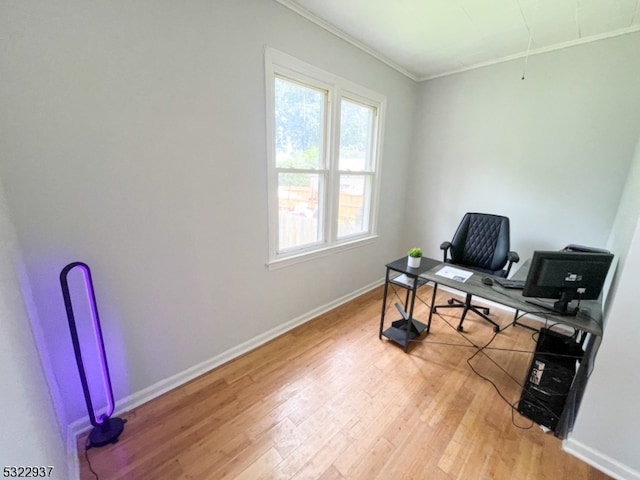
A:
433,213,520,332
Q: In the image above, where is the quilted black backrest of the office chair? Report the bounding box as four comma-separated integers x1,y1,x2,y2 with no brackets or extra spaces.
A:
450,213,509,272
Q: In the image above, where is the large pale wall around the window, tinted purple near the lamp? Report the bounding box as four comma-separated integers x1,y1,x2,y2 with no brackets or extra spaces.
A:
0,0,416,428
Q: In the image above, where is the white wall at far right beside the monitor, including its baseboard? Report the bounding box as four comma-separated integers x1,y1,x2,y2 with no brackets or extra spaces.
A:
565,135,640,479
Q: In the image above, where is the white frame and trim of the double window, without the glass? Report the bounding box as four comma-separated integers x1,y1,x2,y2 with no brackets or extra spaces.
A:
265,47,386,269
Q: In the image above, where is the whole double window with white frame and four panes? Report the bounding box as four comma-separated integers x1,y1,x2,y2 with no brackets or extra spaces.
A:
266,49,385,265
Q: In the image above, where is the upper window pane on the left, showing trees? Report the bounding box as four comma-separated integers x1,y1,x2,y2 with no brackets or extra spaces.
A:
275,78,326,169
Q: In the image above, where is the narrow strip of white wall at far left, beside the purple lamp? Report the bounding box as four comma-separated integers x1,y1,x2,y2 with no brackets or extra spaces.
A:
0,187,69,479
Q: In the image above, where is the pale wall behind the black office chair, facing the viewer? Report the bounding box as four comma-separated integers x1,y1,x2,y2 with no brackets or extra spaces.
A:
407,33,640,266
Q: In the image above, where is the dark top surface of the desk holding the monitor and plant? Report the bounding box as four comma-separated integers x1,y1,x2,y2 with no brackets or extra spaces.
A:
416,257,602,336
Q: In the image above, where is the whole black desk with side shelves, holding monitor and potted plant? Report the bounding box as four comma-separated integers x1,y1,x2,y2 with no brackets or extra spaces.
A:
379,257,602,438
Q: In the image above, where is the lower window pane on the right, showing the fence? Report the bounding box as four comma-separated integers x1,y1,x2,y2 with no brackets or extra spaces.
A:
338,175,371,238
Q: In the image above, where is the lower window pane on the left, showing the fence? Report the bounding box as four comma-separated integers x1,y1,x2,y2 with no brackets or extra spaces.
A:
278,173,323,251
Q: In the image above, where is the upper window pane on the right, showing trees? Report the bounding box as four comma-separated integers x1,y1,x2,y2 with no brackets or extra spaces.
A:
340,99,375,171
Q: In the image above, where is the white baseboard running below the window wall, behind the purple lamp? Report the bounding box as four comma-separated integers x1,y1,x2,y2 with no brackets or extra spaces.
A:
67,279,384,479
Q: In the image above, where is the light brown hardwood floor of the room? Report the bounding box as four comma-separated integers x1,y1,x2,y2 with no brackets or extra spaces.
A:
78,286,609,480
